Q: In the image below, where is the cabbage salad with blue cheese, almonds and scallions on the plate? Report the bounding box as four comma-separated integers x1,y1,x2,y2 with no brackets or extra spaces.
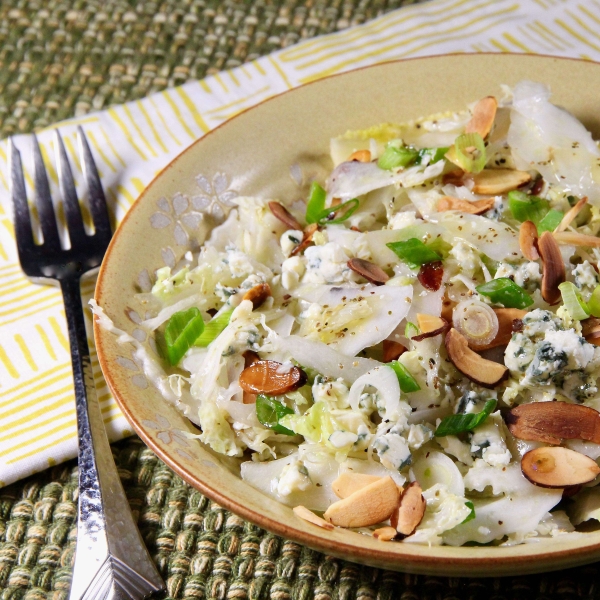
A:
93,81,600,546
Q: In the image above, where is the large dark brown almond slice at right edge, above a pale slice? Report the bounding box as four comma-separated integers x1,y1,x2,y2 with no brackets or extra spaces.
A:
506,402,600,444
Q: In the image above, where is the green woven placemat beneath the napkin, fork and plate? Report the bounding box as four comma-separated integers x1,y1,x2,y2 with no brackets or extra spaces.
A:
0,0,600,600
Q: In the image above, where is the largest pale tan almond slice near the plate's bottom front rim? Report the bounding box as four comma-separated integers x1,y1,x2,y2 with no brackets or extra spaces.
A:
323,477,400,527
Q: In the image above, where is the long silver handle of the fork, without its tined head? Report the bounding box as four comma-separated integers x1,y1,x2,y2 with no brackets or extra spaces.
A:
60,276,164,600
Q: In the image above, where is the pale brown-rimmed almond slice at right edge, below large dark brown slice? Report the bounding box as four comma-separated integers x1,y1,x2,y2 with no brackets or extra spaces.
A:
521,446,600,488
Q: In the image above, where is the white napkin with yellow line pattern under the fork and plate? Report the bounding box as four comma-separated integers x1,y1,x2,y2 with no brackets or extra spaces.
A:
0,0,600,487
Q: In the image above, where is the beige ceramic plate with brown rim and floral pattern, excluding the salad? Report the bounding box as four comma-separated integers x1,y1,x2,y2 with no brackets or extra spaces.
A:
95,55,600,576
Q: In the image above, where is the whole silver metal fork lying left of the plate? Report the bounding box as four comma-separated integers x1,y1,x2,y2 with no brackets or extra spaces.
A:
10,128,164,600
